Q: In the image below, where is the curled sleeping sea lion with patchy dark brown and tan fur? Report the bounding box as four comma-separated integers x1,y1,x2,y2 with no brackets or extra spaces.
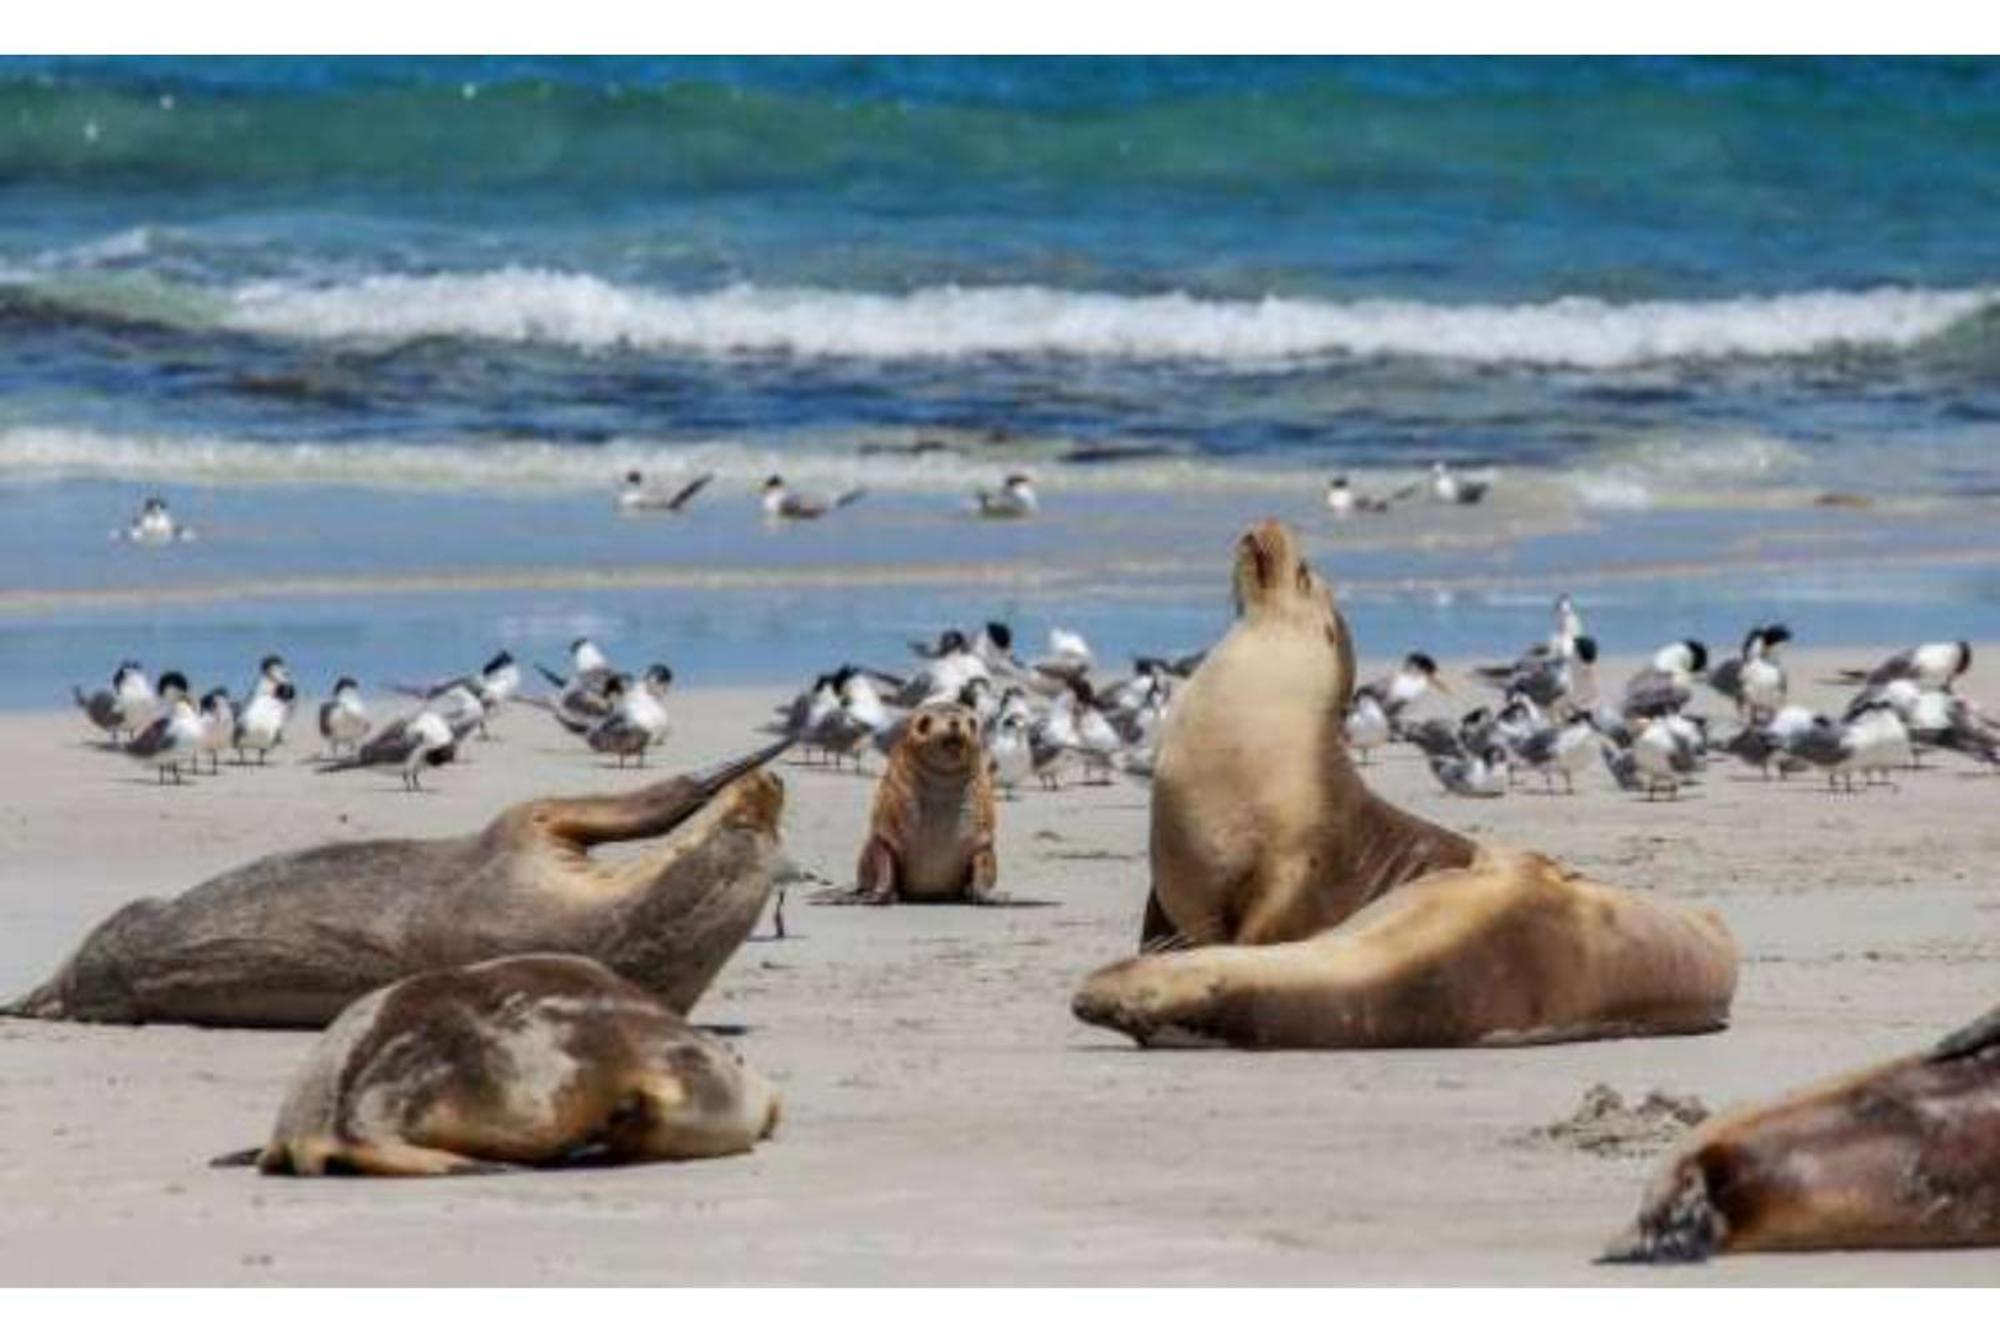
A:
236,956,778,1176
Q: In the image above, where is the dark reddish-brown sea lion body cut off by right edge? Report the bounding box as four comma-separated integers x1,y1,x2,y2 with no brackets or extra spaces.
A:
1604,1008,2000,1262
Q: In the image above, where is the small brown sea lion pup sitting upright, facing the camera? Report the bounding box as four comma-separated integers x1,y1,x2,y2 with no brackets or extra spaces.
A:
854,704,1000,904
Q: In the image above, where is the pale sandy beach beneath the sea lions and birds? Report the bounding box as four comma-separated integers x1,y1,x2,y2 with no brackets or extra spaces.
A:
0,650,2000,1286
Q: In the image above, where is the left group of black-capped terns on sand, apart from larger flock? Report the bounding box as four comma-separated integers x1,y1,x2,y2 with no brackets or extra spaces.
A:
72,638,674,792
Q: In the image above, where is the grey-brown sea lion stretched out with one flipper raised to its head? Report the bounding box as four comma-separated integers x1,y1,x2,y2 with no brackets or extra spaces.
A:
0,740,790,1026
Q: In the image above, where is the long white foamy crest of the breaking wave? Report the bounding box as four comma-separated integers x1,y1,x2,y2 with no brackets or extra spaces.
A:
224,268,2000,370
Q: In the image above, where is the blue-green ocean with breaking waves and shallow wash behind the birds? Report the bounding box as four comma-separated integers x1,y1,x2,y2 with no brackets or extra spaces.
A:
0,58,2000,704
